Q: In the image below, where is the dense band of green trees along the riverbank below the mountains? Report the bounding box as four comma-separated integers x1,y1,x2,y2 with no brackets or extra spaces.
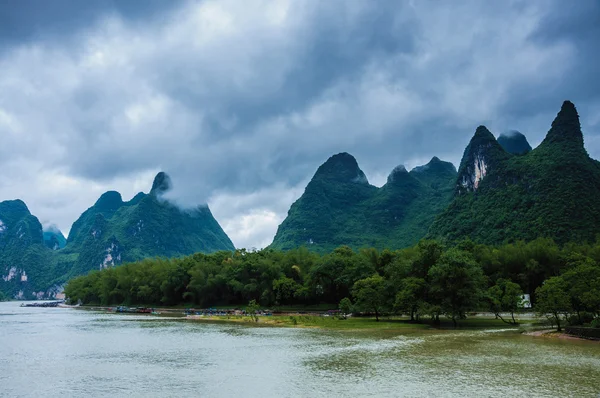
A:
65,239,600,327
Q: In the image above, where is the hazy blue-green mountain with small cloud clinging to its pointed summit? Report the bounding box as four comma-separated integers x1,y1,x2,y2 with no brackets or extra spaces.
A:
58,172,235,276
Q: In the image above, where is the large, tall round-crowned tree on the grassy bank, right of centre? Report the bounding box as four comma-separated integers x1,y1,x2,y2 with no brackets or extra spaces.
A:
429,249,483,326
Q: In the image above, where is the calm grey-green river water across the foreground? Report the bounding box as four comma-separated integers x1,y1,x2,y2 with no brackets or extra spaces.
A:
0,302,600,397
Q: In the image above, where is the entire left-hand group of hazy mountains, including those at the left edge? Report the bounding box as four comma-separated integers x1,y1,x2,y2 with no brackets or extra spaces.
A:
0,173,234,298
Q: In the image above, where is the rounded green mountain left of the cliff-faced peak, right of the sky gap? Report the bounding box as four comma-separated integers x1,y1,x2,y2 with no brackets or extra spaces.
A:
270,153,456,252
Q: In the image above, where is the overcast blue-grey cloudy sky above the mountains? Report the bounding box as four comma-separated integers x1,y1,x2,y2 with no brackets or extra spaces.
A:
0,0,600,247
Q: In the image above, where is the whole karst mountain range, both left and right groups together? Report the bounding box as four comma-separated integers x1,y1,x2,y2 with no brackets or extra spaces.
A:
0,101,600,298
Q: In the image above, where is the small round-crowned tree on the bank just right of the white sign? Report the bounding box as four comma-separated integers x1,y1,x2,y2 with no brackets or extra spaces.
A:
535,276,571,332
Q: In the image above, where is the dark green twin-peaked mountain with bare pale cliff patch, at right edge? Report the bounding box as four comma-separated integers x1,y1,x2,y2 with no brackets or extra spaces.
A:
430,101,600,244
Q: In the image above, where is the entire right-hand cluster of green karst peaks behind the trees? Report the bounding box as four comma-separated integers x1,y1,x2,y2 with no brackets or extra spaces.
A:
271,101,600,252
